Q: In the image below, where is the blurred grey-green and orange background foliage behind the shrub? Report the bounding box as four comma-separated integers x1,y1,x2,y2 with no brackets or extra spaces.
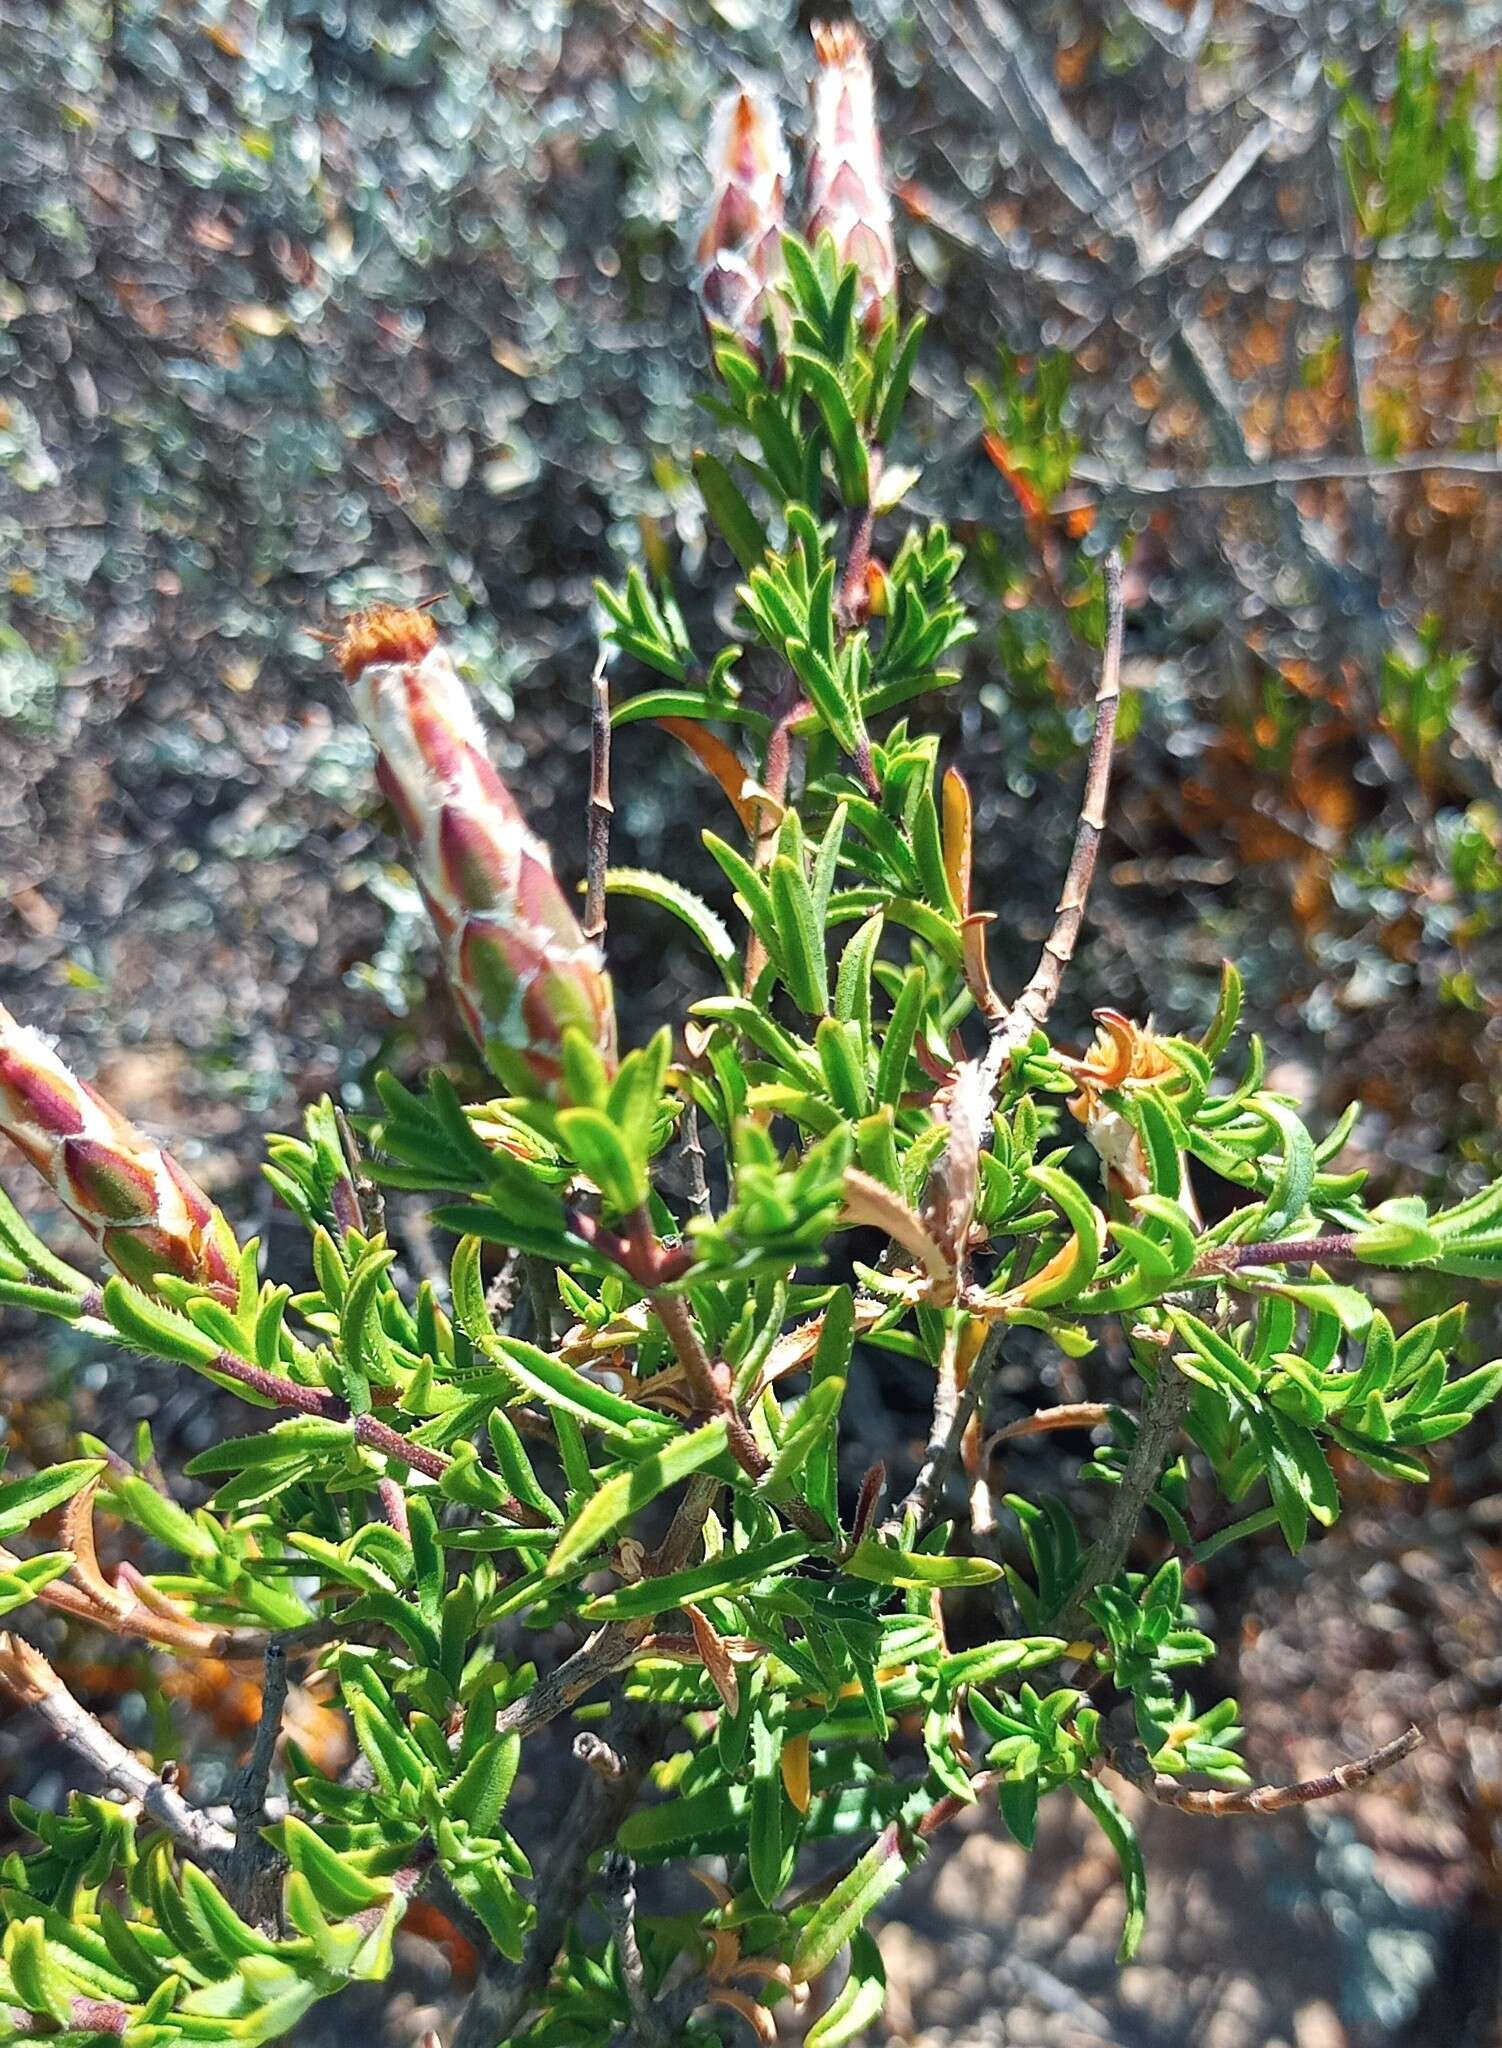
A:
0,0,1502,2048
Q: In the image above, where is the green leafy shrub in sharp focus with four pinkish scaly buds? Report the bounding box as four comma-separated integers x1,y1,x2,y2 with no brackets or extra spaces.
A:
0,31,1502,2048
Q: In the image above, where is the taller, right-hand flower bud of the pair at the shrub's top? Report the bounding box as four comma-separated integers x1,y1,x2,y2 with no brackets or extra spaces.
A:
807,20,898,334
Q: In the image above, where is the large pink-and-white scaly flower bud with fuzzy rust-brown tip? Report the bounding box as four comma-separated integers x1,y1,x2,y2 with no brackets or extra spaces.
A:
338,604,615,1096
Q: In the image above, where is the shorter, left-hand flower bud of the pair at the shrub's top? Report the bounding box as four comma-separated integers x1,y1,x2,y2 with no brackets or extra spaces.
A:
699,90,787,354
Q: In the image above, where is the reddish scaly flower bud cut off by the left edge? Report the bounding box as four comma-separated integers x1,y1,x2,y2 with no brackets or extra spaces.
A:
0,1008,240,1300
